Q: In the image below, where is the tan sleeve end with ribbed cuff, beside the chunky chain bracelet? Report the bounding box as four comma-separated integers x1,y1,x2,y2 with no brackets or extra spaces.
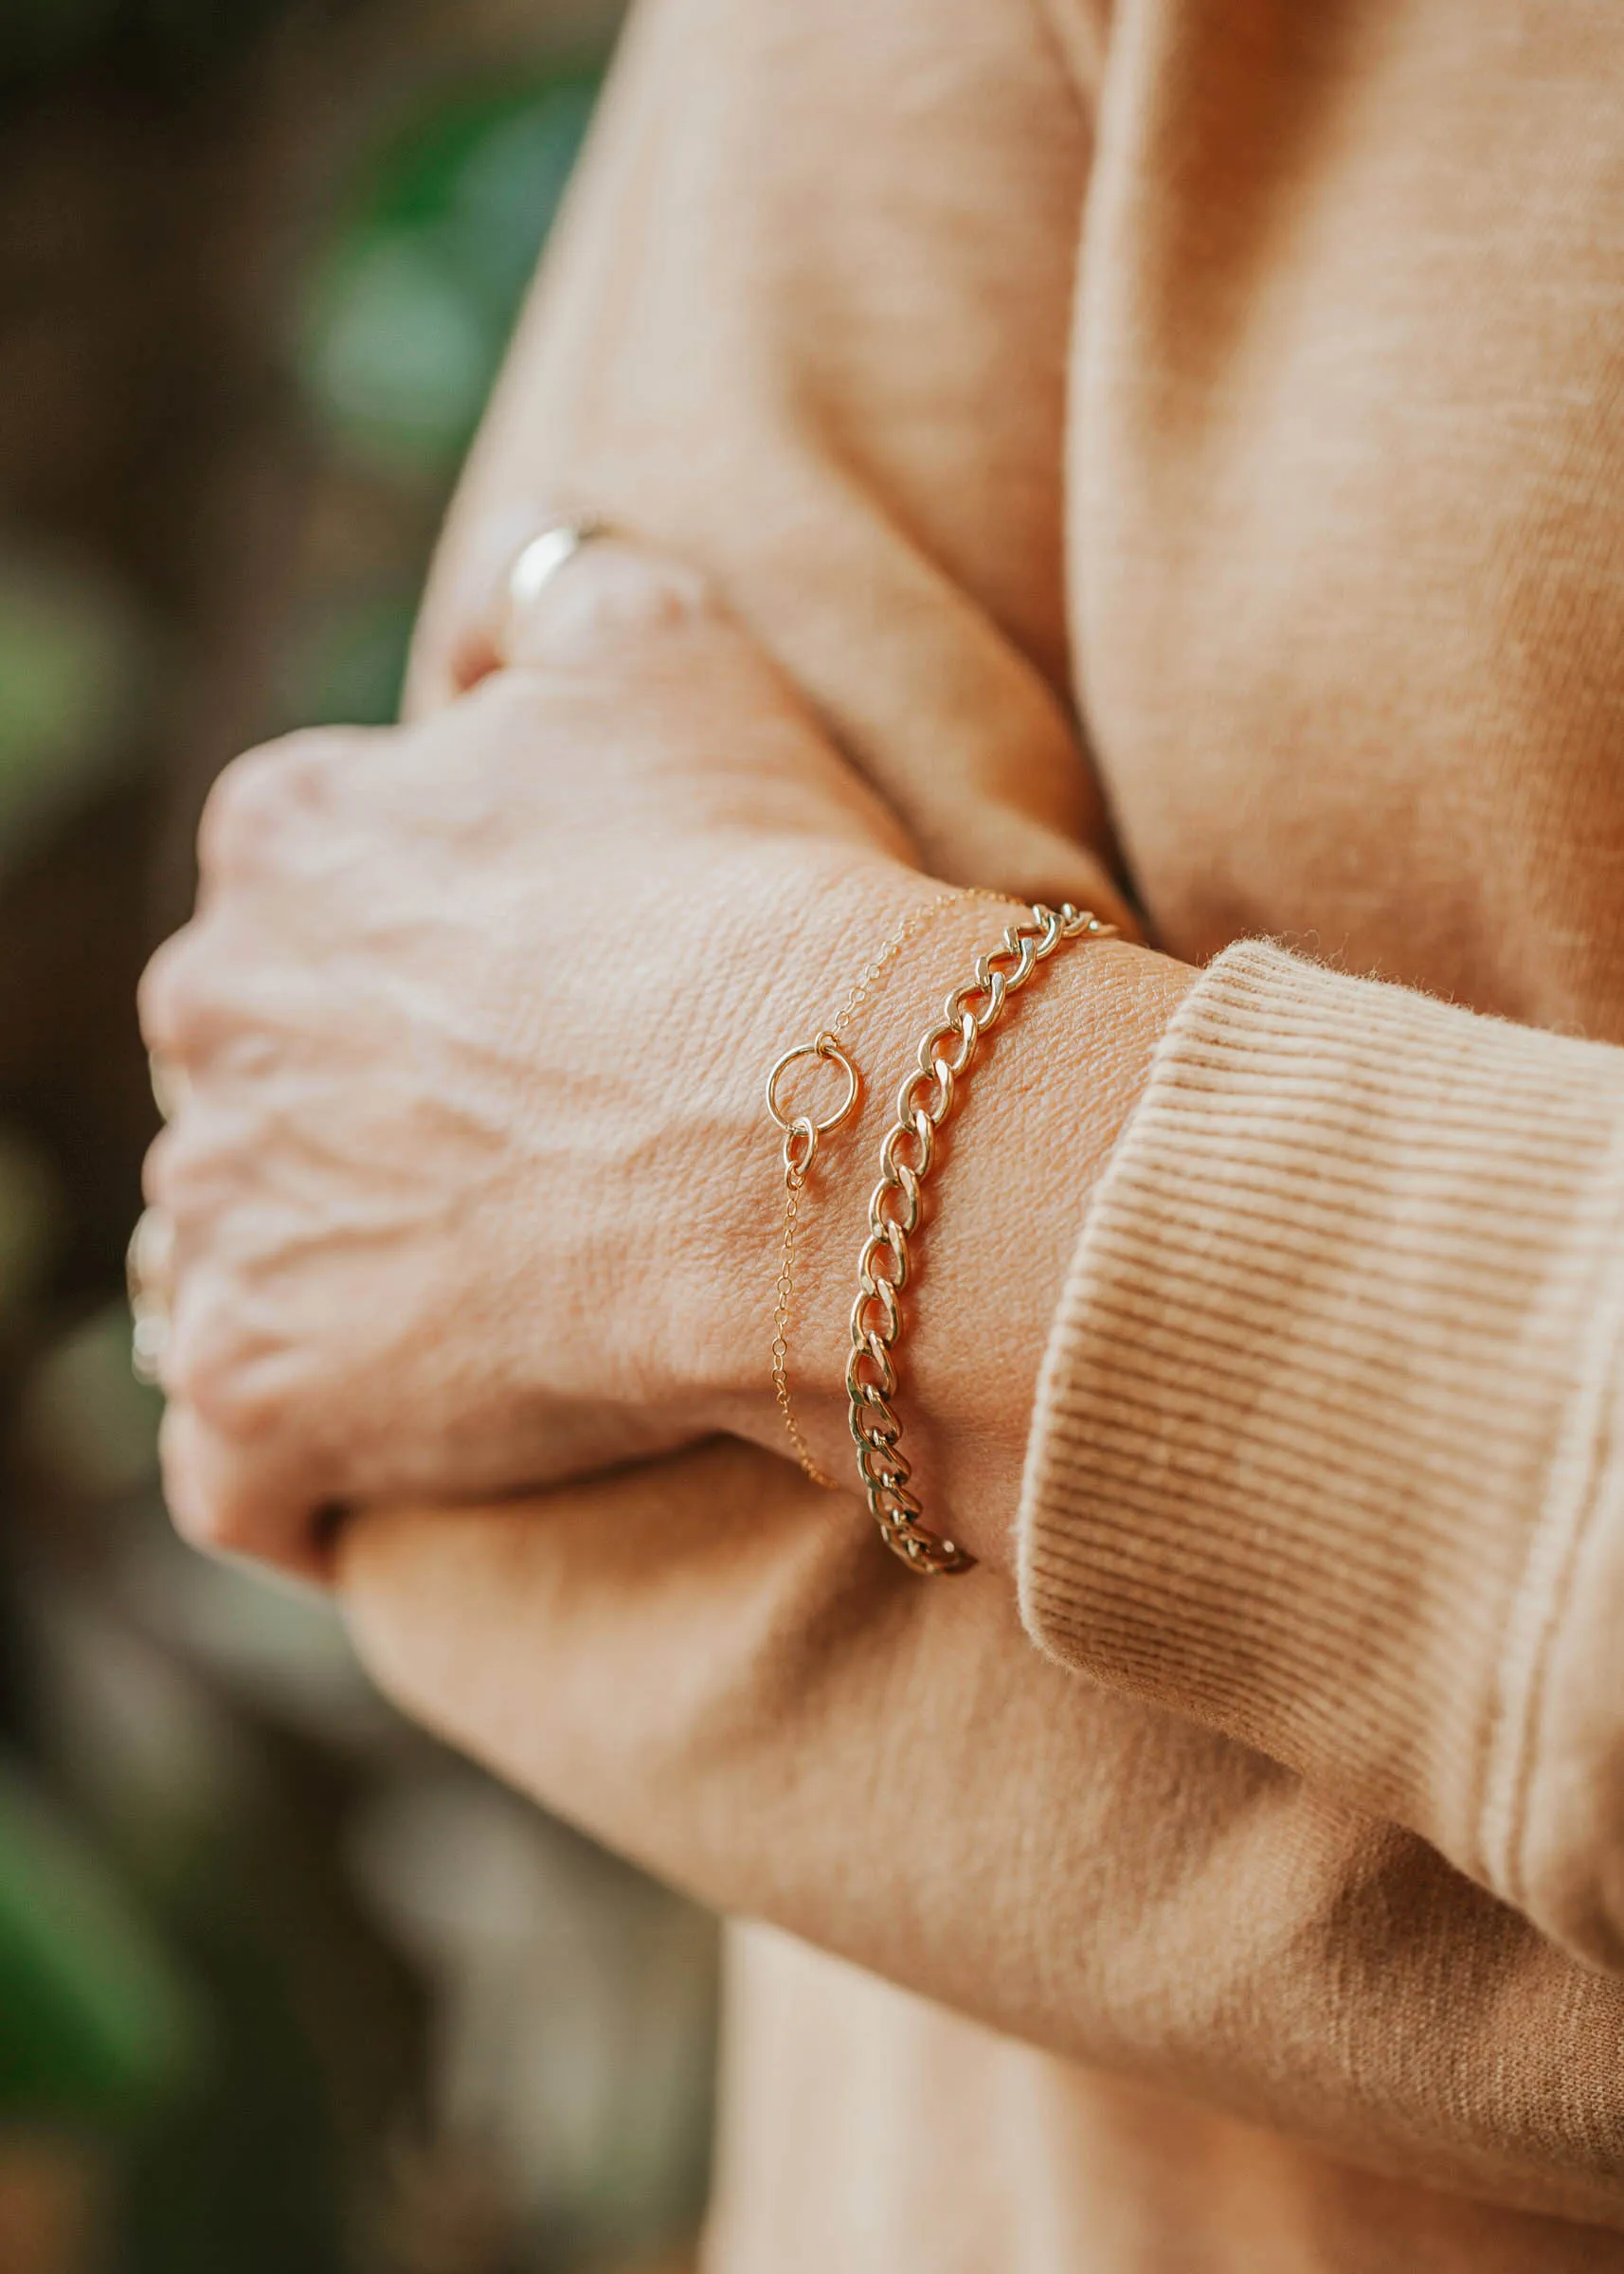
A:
1021,942,1624,1969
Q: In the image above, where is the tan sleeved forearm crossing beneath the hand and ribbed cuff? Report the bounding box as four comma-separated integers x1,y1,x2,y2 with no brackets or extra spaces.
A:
343,1446,1624,2229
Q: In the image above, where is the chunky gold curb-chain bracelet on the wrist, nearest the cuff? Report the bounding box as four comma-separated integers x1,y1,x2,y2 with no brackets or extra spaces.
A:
846,900,1117,1576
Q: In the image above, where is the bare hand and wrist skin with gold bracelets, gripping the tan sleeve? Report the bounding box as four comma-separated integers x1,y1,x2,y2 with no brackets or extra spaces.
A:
141,544,1182,1576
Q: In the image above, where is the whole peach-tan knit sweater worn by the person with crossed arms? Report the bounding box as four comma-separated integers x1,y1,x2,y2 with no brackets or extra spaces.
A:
427,0,1624,2274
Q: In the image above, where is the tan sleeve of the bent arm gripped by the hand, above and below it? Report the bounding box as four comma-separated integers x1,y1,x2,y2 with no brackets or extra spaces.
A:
370,0,1624,2229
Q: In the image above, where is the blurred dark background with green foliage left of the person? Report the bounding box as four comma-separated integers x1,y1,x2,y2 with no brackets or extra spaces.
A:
0,0,714,2274
